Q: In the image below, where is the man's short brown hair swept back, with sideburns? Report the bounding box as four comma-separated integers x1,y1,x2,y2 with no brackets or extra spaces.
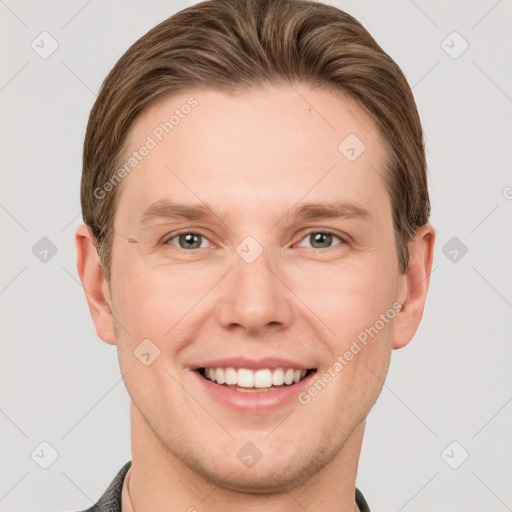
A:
81,0,430,280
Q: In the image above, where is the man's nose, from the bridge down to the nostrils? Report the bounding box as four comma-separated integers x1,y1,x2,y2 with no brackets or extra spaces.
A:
217,245,293,334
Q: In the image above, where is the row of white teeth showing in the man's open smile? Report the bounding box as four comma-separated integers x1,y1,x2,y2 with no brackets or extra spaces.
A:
197,367,316,393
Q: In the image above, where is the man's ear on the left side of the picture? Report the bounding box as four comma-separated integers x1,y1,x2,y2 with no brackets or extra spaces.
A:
75,224,115,345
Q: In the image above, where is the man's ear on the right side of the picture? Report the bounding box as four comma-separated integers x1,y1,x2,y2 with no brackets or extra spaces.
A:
393,223,436,349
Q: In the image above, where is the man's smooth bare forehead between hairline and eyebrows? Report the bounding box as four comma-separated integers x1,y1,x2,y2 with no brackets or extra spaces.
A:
117,84,390,223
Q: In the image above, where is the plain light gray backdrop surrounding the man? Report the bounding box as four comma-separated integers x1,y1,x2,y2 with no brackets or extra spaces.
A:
0,0,512,512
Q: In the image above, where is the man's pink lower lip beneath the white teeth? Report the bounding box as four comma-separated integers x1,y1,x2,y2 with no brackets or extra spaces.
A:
194,371,316,413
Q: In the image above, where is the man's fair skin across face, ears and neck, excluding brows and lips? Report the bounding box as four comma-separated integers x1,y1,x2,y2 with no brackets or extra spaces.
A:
76,84,435,512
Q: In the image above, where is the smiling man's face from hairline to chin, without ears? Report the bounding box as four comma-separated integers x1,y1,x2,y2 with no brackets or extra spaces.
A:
110,84,403,492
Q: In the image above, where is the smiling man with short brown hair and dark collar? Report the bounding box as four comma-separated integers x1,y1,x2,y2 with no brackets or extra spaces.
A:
76,0,435,512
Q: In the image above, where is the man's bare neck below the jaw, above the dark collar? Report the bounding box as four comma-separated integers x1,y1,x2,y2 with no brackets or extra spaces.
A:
129,402,365,512
